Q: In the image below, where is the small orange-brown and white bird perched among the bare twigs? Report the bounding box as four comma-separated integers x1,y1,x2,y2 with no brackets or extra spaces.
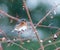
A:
14,20,27,32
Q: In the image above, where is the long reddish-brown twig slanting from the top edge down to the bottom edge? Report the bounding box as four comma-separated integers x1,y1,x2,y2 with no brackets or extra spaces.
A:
23,0,44,50
